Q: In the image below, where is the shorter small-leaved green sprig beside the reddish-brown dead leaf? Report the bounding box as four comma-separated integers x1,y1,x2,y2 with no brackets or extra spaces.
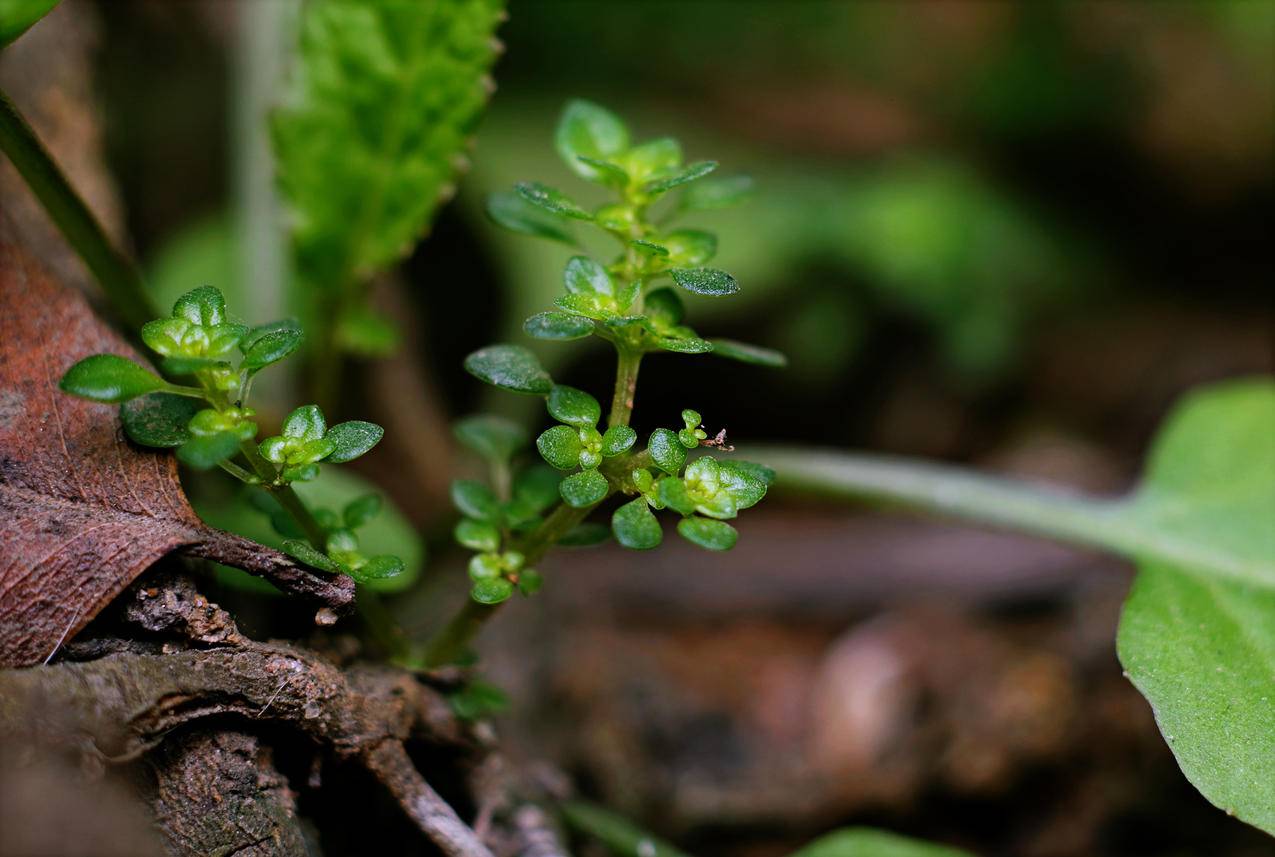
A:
60,286,403,583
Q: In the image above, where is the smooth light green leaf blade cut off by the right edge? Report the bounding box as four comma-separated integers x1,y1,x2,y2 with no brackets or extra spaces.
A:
1117,381,1275,834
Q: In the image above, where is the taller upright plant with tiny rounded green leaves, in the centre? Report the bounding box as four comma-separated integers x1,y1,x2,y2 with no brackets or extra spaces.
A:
422,101,784,666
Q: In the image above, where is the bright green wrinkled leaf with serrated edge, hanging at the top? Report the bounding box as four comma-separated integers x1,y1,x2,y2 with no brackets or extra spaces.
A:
273,0,504,298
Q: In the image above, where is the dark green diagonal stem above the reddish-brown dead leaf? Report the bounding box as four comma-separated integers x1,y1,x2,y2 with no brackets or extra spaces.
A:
0,91,161,329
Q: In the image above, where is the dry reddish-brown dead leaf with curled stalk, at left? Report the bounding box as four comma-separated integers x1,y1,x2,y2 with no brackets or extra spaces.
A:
0,237,353,667
